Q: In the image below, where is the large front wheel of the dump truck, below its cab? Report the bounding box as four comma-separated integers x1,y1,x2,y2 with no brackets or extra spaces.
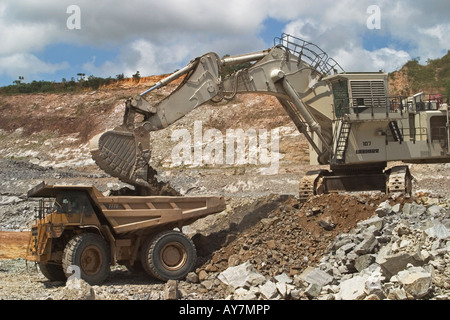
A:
63,233,111,285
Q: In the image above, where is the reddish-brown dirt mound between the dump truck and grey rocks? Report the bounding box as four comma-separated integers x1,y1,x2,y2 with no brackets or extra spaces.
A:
197,194,402,276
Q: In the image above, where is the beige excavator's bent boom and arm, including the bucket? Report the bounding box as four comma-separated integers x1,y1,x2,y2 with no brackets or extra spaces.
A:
91,37,340,194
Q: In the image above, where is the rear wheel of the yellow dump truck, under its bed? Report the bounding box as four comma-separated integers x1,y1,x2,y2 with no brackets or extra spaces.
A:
141,231,197,281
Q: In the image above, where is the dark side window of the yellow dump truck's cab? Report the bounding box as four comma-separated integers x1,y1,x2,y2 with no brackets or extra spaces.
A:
55,191,94,215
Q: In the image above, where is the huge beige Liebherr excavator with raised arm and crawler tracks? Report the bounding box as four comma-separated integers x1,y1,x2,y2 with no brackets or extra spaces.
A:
91,34,450,199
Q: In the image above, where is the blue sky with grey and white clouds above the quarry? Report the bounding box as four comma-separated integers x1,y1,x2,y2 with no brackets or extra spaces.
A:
0,0,450,86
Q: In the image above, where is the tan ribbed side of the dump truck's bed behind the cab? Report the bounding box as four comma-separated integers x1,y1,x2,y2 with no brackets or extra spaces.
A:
97,196,226,234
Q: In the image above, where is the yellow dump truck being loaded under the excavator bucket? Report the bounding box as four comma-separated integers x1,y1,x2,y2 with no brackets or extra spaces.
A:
27,182,225,284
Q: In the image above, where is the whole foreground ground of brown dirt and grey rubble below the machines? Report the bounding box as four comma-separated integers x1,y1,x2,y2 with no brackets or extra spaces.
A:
0,190,450,300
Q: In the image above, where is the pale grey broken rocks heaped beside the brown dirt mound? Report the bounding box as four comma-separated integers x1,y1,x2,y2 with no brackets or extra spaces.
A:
189,192,450,300
